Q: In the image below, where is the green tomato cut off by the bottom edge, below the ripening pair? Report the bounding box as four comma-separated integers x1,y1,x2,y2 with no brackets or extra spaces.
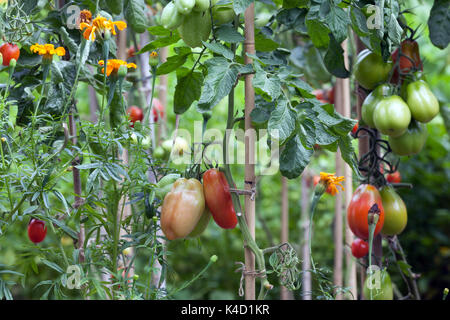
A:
363,269,394,300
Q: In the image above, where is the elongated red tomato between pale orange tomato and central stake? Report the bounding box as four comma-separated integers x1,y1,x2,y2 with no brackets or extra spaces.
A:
203,169,238,229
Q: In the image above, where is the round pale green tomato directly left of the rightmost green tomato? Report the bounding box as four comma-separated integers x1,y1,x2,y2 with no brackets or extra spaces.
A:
373,95,411,137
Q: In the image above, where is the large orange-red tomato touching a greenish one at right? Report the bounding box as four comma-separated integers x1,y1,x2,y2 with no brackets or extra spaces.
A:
347,184,384,240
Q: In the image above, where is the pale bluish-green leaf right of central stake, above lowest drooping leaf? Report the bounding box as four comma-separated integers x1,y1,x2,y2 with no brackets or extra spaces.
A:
268,99,297,144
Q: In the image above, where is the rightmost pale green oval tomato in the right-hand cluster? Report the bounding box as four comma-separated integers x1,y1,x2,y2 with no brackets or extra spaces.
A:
406,80,439,123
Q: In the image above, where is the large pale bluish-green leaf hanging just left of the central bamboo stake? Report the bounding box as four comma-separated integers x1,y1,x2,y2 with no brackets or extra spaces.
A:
198,57,242,111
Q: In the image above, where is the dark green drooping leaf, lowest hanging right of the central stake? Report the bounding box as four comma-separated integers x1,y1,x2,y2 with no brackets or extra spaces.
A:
280,135,314,179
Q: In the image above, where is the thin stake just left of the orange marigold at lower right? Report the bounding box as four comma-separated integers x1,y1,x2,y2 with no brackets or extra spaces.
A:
300,170,312,300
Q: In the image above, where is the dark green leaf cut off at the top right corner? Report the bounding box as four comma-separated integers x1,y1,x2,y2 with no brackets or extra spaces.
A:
428,0,450,49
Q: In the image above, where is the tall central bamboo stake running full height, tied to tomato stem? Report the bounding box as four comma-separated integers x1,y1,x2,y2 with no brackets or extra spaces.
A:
244,3,255,300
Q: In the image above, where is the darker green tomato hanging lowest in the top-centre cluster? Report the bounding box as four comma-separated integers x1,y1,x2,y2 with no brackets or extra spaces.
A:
178,10,211,48
